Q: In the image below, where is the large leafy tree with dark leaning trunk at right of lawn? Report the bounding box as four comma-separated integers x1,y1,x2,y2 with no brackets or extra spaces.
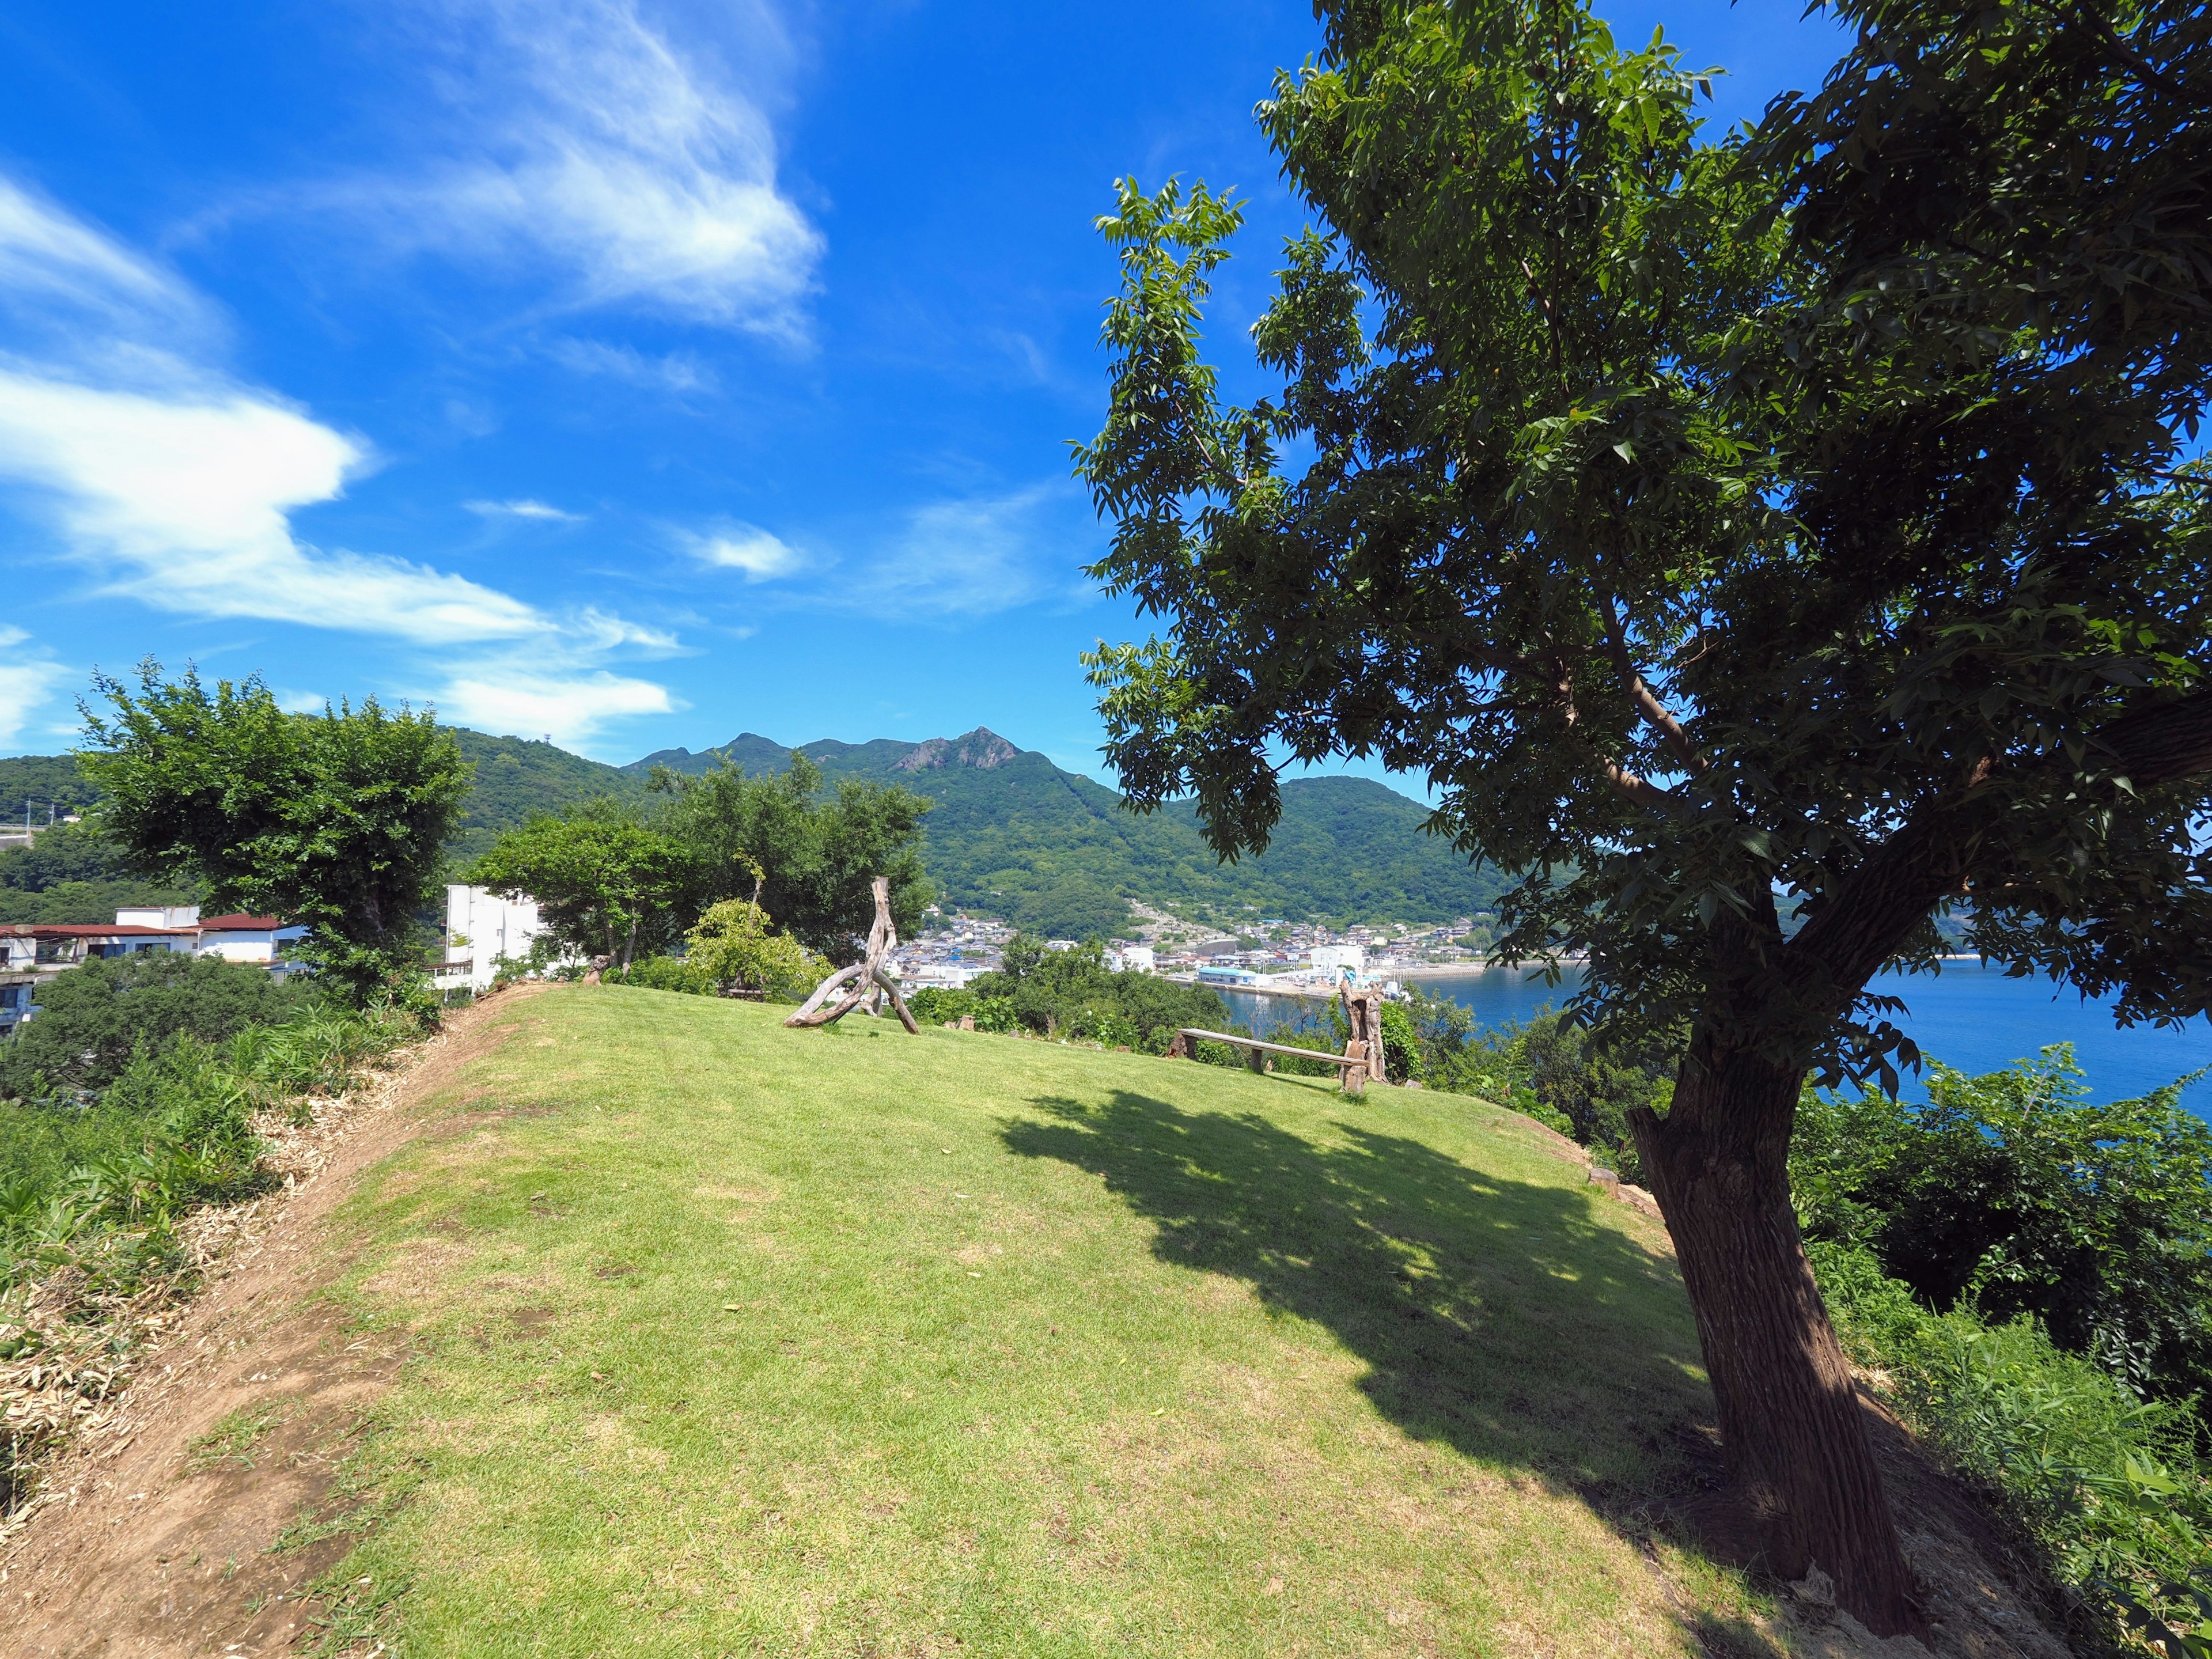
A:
1077,0,2212,1633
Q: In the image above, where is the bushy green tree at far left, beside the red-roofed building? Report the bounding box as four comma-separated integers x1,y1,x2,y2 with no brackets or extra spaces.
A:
77,659,469,1002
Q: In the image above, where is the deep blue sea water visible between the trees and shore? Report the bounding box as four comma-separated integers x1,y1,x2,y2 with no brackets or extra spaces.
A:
1228,962,2212,1117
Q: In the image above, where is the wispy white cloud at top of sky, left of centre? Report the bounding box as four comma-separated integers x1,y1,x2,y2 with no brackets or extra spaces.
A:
312,0,823,336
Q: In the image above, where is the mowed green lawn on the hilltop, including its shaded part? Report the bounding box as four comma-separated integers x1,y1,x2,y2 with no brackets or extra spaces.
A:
312,987,1770,1659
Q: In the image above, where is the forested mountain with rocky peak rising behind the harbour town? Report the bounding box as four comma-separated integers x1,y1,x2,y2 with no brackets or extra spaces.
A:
626,728,1504,938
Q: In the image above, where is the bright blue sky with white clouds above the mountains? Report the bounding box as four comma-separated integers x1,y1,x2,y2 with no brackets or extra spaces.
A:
0,0,1838,774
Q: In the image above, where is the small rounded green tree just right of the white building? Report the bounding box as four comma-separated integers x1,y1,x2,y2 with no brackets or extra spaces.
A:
471,803,684,969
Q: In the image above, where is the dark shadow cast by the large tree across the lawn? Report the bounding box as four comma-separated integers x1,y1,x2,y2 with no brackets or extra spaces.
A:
1002,1090,1774,1652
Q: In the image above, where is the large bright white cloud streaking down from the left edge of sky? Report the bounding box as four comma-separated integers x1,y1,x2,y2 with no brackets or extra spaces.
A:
0,166,677,732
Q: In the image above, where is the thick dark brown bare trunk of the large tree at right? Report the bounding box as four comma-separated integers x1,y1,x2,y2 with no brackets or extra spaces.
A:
1630,1035,1925,1637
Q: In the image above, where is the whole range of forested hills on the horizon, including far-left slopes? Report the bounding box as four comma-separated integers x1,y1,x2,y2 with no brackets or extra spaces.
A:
0,728,1502,938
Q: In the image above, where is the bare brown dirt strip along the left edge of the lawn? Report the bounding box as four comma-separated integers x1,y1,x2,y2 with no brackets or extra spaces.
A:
0,987,533,1659
